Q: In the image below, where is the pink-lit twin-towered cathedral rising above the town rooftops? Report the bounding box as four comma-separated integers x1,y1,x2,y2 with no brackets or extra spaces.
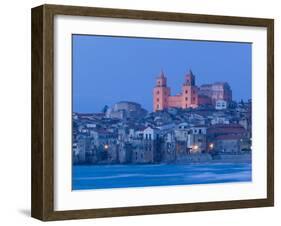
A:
153,70,232,111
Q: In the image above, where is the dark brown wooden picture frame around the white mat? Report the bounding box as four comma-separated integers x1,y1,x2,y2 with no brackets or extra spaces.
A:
31,5,274,221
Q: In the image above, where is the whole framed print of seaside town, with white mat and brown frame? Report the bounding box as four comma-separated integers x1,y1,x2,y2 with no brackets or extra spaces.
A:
32,5,274,221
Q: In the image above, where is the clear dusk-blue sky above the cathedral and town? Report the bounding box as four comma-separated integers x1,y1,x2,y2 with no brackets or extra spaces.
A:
73,35,252,112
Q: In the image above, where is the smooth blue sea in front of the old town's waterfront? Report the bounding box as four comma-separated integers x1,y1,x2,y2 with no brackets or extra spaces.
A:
72,163,252,190
